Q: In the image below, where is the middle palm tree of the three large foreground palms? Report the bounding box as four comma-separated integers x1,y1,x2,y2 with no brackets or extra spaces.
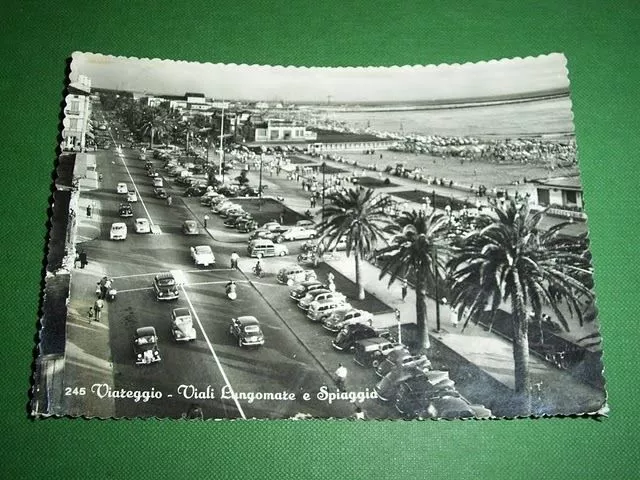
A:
376,210,450,350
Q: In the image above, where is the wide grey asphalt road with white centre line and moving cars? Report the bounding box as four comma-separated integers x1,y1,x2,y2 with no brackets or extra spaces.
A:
71,144,394,418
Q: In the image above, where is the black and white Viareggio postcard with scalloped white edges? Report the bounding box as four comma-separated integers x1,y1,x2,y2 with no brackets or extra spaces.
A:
30,52,608,420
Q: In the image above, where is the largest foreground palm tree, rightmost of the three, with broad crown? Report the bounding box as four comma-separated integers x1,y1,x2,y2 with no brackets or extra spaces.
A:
447,201,593,411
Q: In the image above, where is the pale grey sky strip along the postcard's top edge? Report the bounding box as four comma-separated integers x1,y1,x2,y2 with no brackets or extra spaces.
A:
70,52,569,104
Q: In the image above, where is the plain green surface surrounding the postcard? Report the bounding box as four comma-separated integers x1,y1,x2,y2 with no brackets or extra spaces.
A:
0,0,640,479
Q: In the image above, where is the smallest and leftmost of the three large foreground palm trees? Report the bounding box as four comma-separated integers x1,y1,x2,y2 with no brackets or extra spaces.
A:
318,188,392,300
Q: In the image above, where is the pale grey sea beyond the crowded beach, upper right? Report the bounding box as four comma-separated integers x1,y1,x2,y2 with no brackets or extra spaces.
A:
325,95,575,139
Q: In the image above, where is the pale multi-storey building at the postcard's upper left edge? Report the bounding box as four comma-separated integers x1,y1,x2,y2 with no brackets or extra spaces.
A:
61,75,93,151
